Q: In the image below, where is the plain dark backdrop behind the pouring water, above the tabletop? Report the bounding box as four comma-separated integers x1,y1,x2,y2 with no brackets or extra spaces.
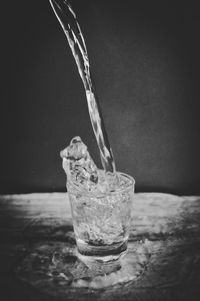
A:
0,0,200,194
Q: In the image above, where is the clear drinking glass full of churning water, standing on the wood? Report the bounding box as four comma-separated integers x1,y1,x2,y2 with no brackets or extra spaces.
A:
67,172,135,263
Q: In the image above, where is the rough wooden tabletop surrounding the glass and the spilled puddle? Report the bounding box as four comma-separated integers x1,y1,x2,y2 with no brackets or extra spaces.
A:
0,193,200,301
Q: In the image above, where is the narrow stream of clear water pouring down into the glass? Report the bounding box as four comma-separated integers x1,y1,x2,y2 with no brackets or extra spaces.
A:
49,0,116,174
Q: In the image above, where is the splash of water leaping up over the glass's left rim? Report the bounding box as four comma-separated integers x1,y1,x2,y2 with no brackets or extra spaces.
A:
60,136,98,191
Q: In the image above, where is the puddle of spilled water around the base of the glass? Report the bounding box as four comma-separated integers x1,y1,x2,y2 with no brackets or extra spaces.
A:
15,240,151,297
